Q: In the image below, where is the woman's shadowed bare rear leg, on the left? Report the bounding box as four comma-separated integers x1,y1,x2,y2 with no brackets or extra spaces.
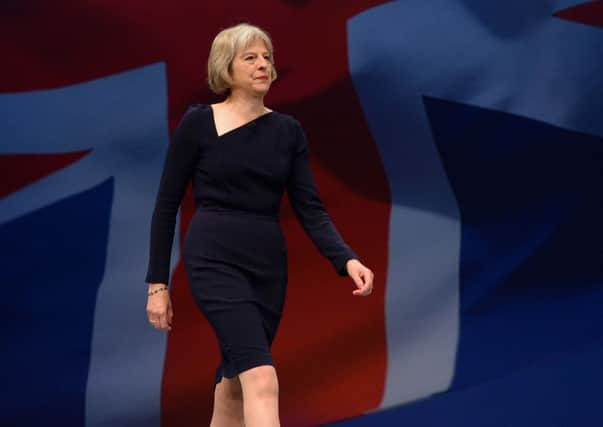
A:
209,377,245,427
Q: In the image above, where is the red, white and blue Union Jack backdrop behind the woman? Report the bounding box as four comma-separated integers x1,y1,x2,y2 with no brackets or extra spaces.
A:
0,0,603,427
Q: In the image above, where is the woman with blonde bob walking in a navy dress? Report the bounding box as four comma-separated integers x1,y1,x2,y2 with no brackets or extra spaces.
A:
146,24,373,427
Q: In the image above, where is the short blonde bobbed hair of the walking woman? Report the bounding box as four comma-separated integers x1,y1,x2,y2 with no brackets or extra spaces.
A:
207,23,277,95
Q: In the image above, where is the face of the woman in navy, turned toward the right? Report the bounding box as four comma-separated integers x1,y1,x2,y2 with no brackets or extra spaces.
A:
230,40,272,96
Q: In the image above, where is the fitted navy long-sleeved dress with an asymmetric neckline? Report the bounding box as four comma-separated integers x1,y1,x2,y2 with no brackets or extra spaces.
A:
146,104,358,383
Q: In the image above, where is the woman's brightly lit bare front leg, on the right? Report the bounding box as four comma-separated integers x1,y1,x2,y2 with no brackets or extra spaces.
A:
239,365,280,427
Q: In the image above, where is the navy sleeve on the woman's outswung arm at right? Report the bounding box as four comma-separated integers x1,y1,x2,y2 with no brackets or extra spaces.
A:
287,121,358,276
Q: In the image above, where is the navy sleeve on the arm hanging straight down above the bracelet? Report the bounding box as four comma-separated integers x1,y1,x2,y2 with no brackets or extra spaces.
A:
145,108,199,284
